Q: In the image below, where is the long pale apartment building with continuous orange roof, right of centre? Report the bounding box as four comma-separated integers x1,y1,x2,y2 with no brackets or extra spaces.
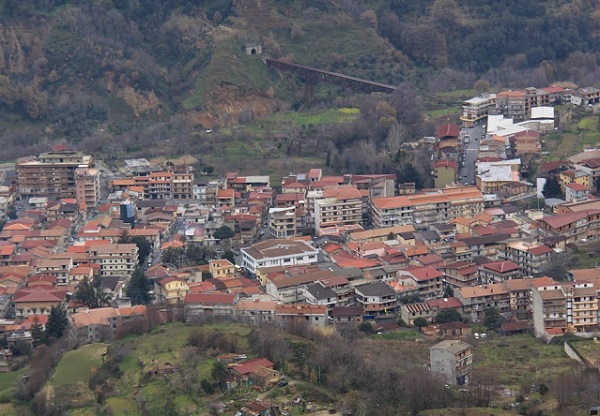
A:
371,187,483,228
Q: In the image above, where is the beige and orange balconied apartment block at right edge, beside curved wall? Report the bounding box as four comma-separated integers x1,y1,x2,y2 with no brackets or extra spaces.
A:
532,281,598,337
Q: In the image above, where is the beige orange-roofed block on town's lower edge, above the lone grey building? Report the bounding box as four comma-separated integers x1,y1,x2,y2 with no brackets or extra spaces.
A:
454,283,510,322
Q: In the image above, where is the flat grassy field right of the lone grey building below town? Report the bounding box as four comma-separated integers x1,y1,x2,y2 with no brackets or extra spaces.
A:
473,335,577,389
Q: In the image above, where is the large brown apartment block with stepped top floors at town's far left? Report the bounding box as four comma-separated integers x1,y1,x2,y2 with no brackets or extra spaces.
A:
15,147,94,199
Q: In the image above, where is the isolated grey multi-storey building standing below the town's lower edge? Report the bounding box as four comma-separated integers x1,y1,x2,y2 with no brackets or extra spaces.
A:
429,340,473,385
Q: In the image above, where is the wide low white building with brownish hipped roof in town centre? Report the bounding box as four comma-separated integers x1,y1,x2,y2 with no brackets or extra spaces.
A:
241,238,320,276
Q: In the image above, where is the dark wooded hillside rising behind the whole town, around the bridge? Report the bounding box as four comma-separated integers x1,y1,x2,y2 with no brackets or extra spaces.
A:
0,0,600,177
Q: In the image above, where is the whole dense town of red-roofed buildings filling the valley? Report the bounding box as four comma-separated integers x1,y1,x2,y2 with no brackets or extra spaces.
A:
0,83,600,394
